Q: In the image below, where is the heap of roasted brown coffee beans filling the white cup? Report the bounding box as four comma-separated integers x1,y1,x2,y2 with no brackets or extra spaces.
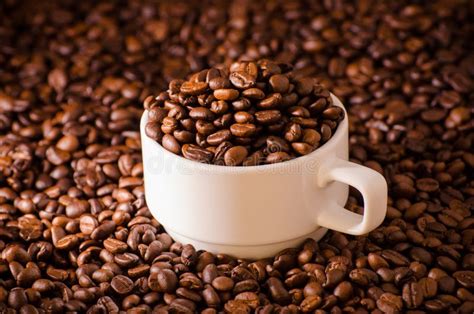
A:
144,60,344,166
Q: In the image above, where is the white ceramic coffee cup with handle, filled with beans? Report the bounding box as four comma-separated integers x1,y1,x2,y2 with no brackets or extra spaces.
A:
140,95,387,259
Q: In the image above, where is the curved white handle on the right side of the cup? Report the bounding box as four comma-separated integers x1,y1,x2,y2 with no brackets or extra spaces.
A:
316,158,387,235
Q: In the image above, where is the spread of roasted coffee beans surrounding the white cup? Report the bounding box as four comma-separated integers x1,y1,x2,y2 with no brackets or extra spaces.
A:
0,0,474,314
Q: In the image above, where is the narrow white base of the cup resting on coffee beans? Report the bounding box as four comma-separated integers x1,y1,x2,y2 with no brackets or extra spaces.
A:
165,227,328,260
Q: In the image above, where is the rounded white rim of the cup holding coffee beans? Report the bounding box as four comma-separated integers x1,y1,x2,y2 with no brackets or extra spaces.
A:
140,93,349,174
